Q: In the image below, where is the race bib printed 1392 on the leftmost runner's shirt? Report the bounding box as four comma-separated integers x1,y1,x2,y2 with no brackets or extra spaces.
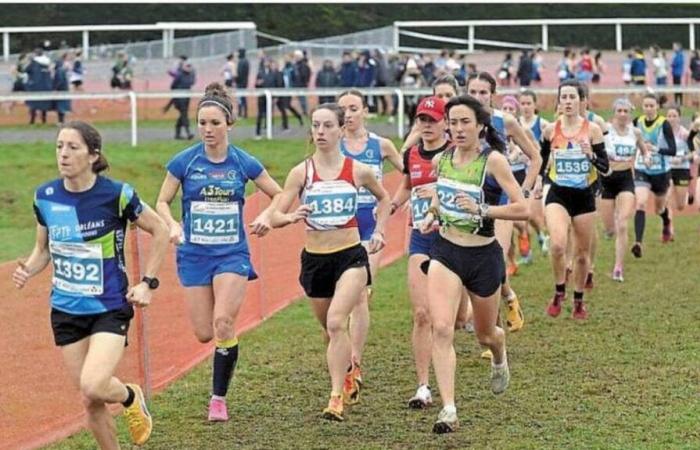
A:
49,241,104,296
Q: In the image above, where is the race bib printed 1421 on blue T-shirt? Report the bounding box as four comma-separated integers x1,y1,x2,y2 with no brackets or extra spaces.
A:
190,202,240,245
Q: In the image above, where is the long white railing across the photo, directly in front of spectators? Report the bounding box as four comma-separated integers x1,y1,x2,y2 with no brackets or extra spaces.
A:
5,86,700,147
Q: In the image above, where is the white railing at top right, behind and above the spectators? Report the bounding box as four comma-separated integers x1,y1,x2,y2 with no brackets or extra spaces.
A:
393,17,700,52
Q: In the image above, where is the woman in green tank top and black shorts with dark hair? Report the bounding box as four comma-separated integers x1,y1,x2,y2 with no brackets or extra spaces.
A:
421,95,529,433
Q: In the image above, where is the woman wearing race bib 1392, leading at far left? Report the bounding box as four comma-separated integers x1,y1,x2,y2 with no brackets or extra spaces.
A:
12,121,168,448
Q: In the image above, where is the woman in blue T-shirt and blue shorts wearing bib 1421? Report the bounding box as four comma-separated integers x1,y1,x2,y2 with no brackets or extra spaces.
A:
157,83,282,422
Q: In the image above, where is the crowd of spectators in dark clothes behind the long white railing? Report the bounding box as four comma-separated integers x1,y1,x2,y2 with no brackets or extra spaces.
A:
12,43,700,127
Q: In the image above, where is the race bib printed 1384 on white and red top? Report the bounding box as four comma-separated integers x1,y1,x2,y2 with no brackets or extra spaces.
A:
303,180,358,228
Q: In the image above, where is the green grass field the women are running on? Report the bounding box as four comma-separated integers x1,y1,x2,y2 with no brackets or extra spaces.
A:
5,141,700,449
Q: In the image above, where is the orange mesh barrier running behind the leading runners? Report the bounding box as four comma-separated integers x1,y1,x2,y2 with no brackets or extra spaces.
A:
0,172,409,450
